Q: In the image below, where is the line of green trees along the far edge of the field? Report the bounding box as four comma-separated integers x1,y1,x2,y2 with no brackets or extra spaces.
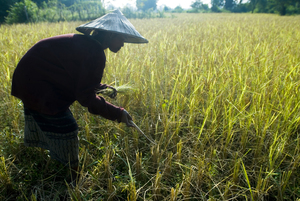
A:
0,0,300,24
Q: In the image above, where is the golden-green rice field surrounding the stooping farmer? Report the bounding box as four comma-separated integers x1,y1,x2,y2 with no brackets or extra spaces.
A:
0,14,300,201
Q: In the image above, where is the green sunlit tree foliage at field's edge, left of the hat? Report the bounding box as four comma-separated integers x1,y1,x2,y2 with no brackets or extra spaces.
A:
4,0,105,24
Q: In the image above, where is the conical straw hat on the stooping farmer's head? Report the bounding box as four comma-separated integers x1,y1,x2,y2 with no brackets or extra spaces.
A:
76,9,148,43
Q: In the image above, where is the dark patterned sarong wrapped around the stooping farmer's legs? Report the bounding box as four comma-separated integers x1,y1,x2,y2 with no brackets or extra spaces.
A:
24,107,79,166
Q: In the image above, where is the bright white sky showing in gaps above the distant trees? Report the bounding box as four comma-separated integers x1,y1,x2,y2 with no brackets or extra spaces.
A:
104,0,211,8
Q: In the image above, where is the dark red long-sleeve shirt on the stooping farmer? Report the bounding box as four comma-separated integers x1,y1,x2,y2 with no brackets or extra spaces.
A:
11,34,123,120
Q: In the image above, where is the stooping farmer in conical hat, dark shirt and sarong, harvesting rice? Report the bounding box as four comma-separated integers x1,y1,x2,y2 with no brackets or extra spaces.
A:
11,10,148,181
